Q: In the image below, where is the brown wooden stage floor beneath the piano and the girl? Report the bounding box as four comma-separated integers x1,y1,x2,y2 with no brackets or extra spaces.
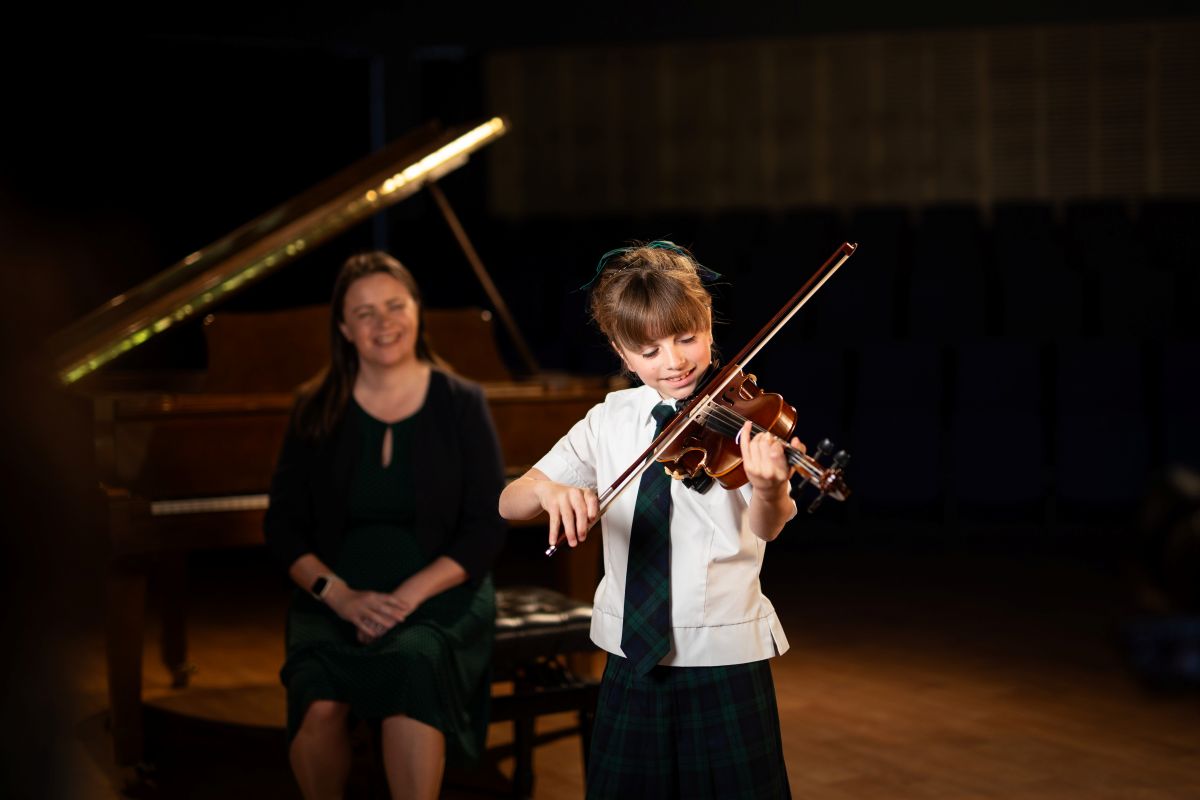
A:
51,525,1200,800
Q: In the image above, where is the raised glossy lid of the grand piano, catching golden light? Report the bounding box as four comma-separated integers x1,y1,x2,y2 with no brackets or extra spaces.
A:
49,116,508,385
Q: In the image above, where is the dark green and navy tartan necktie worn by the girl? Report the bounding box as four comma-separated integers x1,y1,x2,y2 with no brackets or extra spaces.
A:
620,403,676,674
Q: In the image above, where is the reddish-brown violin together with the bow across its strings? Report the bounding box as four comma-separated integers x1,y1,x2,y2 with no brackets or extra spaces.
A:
546,242,858,557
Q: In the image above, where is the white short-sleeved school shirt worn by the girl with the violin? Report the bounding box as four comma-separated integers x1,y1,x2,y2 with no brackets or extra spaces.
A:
534,386,796,667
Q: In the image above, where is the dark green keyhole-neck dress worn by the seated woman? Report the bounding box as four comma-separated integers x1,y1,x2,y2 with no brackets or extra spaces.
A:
280,401,496,764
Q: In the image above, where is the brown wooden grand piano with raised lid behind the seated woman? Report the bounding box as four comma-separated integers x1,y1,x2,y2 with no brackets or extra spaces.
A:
50,118,614,766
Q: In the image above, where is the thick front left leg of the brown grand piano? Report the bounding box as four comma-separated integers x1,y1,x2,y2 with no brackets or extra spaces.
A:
104,559,146,766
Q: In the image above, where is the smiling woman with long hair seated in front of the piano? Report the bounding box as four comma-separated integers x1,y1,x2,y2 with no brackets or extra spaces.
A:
264,252,505,798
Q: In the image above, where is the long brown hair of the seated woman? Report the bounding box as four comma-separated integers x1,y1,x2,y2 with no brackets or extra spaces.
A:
295,251,442,441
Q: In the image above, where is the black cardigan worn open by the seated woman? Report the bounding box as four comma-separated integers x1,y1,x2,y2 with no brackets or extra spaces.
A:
263,369,506,581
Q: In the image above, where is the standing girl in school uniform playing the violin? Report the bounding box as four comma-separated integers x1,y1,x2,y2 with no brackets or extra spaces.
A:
500,241,802,800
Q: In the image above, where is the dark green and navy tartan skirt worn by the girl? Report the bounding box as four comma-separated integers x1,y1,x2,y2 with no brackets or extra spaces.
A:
587,655,792,800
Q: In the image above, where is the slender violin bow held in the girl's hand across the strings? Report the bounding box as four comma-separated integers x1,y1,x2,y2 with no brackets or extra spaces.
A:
546,242,858,558
